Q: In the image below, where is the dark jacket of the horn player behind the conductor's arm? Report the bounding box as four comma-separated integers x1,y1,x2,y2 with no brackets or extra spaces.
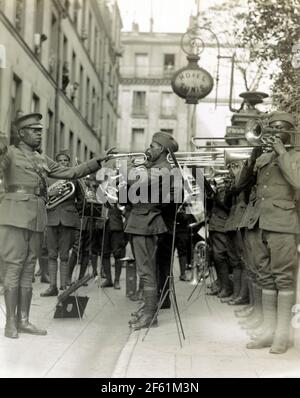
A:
47,181,80,229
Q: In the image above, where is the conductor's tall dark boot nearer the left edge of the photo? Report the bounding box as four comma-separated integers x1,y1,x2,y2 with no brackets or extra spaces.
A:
4,287,19,339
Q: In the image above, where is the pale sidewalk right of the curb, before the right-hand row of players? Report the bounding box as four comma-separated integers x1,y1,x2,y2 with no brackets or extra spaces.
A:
112,277,300,378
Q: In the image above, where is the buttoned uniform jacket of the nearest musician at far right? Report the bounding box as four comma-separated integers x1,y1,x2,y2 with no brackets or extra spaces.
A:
248,150,300,234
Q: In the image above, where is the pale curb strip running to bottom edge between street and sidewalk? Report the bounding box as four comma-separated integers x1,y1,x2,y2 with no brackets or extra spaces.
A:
111,331,140,379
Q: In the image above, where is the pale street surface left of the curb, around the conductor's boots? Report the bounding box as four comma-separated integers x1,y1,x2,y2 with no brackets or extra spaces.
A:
0,270,135,378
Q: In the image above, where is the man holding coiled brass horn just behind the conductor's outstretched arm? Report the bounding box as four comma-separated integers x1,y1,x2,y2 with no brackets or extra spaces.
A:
41,151,80,297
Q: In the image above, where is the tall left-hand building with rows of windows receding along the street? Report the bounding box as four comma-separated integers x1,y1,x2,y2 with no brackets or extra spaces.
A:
0,0,122,161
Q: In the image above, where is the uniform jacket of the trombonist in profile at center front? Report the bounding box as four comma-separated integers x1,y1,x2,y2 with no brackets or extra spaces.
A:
125,156,169,236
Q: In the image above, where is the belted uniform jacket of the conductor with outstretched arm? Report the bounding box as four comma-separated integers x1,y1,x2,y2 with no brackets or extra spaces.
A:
0,144,99,232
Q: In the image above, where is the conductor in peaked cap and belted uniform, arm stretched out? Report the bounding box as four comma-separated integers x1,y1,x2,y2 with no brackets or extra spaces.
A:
0,113,112,338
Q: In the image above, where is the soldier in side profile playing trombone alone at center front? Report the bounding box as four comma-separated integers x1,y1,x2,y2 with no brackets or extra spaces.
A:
125,132,178,330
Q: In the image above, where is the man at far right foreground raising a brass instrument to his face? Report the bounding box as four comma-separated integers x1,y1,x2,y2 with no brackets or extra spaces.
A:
247,112,300,354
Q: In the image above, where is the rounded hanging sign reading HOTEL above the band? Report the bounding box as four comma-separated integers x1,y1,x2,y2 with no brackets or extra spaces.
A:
171,57,214,104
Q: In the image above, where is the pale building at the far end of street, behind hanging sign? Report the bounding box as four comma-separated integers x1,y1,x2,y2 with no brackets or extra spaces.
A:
118,24,272,151
